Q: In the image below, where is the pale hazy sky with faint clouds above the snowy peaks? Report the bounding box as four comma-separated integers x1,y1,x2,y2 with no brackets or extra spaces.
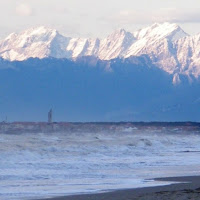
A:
0,0,200,38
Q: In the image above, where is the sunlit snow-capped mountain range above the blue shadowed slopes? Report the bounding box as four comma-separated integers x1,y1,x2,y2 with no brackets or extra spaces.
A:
0,22,200,83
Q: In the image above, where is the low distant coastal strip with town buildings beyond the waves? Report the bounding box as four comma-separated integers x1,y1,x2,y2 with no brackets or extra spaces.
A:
0,122,200,134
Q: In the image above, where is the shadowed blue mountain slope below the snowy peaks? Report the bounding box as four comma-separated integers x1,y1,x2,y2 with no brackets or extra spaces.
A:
0,55,200,121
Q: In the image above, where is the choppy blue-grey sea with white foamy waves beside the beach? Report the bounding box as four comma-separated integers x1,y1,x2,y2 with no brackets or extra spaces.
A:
0,129,200,200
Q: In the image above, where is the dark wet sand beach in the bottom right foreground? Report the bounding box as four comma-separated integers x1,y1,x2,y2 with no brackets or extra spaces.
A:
36,176,200,200
